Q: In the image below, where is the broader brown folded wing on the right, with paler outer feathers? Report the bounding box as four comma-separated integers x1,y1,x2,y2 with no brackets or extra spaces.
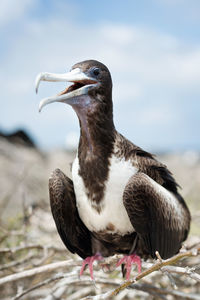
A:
123,172,190,259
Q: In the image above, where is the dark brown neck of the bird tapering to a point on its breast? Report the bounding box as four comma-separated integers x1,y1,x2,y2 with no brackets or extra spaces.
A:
75,107,116,211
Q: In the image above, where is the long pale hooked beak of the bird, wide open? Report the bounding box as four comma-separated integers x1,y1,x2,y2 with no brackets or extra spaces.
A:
35,68,97,111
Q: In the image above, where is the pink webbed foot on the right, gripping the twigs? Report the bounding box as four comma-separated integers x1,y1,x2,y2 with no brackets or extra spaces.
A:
117,254,142,280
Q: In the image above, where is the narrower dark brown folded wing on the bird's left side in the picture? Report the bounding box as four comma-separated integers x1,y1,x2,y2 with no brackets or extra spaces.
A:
49,169,92,258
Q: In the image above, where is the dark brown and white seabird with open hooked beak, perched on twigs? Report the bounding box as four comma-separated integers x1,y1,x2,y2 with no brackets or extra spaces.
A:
36,60,191,280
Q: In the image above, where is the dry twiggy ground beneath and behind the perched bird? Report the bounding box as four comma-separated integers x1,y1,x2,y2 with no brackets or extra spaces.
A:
0,138,200,300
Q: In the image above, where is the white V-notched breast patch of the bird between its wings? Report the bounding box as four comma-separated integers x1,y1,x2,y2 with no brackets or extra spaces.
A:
72,155,137,234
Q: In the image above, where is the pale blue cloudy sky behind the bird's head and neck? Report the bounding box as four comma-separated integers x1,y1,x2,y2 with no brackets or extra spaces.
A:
0,0,200,151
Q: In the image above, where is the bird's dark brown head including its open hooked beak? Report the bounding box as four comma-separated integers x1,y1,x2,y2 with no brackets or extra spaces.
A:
36,60,112,114
